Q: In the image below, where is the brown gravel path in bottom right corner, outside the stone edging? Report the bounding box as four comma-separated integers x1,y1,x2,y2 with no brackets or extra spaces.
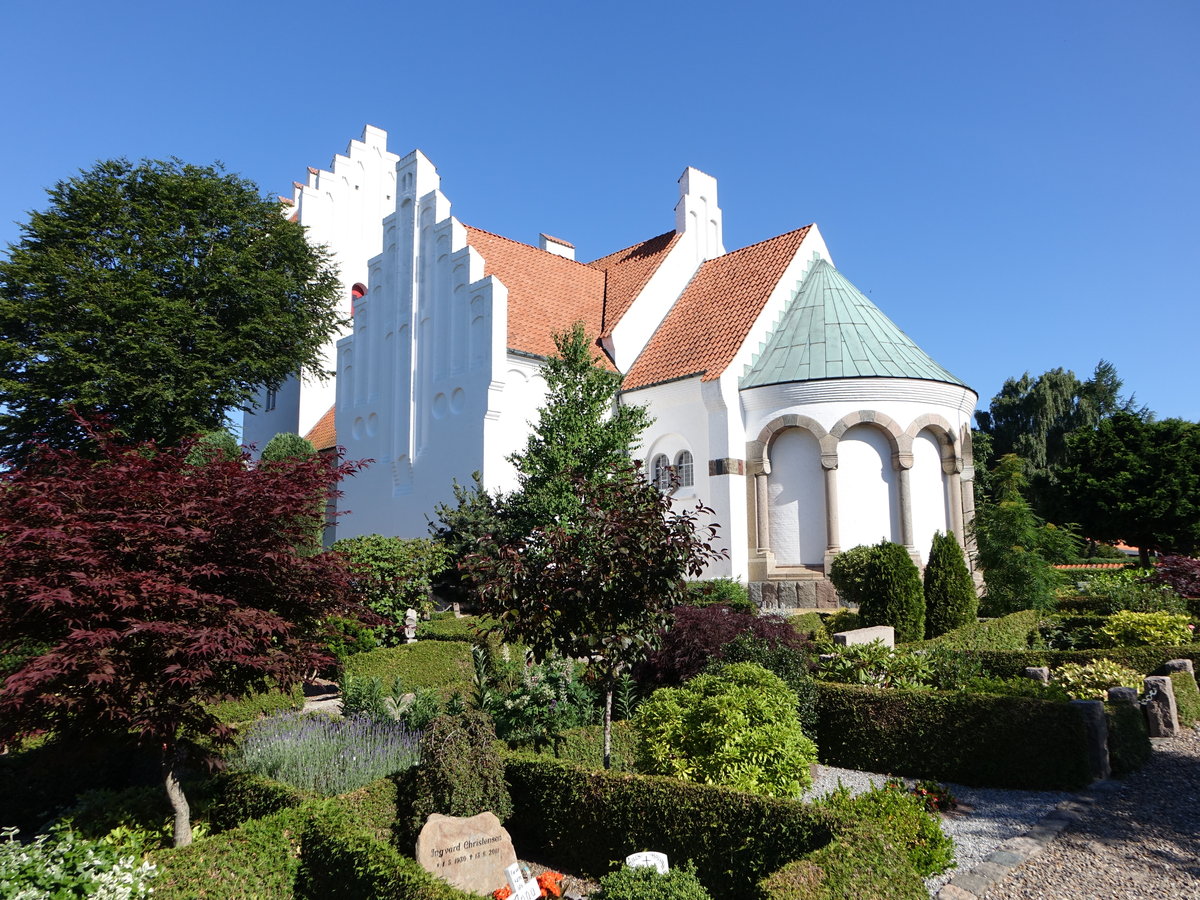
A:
984,730,1200,900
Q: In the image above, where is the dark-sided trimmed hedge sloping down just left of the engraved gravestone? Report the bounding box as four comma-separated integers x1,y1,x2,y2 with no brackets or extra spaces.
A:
294,803,480,900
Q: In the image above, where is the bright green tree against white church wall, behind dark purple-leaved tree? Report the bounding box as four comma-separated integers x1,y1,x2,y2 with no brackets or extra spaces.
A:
509,323,650,534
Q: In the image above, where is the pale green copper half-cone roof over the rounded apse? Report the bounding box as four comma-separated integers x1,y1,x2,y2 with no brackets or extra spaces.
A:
740,259,966,388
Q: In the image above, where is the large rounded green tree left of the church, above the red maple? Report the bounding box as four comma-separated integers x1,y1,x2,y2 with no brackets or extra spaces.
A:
0,160,340,456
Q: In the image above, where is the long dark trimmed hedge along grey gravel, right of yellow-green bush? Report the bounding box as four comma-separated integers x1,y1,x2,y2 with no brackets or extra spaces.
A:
816,683,1091,791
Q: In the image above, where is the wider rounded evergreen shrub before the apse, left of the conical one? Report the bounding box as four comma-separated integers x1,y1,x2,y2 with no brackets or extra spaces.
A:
829,541,925,643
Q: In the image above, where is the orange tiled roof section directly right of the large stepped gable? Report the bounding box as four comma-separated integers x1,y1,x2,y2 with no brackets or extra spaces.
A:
466,226,612,368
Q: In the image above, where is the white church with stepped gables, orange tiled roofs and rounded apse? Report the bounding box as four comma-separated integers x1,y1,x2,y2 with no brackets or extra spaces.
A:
244,126,977,607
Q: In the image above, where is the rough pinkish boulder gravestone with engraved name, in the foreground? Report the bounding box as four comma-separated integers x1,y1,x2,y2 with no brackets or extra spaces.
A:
416,812,517,894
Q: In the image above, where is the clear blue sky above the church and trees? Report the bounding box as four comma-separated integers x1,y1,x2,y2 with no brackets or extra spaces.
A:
0,0,1200,421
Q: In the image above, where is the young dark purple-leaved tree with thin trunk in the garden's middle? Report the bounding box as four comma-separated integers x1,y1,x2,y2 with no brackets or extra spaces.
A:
462,463,727,768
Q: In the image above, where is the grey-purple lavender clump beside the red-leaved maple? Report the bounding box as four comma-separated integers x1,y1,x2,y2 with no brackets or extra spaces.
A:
230,713,420,796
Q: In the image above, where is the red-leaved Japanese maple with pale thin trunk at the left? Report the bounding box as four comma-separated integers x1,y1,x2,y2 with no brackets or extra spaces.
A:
0,428,359,846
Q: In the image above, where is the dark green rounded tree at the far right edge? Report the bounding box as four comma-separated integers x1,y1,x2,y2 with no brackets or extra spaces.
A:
1062,413,1200,565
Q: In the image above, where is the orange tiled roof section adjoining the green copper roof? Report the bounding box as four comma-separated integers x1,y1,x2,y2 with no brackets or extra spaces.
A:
622,226,811,391
